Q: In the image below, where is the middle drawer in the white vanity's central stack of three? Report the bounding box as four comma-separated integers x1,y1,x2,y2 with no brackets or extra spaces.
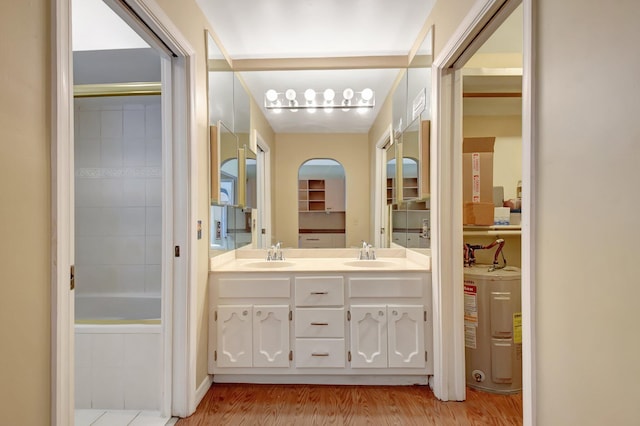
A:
295,308,345,337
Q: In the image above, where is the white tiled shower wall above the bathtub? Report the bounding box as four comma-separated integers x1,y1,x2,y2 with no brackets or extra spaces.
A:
75,96,162,294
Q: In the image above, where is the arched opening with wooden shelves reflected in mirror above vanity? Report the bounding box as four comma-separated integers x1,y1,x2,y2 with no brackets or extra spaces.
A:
298,159,346,248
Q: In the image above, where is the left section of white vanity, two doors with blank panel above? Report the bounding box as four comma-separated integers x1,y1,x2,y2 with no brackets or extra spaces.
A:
210,277,291,368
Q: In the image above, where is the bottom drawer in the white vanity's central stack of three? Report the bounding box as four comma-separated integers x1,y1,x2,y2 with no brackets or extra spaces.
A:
294,339,345,368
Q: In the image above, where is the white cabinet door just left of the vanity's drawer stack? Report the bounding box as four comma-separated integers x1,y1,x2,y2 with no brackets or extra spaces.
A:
253,305,289,367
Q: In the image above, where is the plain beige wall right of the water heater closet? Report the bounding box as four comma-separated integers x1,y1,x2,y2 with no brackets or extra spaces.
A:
533,0,640,425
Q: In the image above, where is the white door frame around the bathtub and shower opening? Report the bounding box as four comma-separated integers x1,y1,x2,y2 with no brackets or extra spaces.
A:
51,0,198,426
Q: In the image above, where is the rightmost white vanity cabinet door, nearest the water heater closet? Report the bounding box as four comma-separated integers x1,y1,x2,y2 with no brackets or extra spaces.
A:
387,305,425,368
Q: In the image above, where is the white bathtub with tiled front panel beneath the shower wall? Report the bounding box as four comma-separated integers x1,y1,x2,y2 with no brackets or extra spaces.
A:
75,294,163,411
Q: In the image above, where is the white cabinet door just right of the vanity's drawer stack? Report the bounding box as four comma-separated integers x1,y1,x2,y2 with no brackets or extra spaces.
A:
349,305,387,368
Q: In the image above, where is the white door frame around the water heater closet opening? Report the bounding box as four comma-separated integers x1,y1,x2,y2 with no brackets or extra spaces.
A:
431,0,536,425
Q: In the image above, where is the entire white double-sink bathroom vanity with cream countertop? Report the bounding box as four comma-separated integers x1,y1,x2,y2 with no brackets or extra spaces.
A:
209,249,433,384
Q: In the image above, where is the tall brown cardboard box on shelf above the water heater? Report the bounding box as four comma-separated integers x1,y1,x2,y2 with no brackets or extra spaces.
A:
462,137,496,203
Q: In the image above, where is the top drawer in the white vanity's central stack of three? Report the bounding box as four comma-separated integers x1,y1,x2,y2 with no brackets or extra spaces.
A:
295,277,344,306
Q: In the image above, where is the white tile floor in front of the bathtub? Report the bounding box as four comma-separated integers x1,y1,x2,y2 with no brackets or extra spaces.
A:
75,409,178,426
